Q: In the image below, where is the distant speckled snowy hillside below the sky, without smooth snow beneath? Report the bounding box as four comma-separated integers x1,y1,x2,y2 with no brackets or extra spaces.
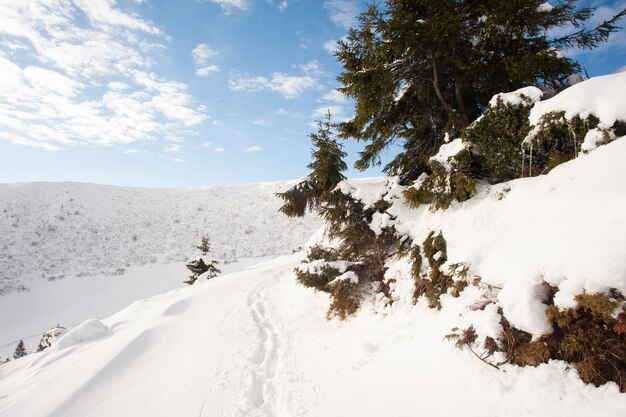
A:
0,183,320,294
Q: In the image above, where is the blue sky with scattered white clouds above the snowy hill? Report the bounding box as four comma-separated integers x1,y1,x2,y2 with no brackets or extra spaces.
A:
0,0,626,187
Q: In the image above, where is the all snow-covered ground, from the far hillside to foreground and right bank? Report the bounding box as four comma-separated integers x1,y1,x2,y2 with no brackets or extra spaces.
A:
0,77,626,417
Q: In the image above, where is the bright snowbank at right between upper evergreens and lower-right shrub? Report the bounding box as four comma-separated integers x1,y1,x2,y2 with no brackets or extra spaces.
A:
343,136,626,335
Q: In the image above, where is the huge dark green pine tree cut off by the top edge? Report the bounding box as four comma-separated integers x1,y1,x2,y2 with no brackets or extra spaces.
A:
336,0,626,182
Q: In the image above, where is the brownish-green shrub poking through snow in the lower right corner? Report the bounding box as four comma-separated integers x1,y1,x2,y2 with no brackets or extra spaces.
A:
446,287,626,392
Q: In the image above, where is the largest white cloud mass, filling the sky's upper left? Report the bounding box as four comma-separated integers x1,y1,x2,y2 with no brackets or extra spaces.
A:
0,0,207,150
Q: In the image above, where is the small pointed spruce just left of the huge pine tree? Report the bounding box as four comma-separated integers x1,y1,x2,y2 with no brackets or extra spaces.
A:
276,112,347,217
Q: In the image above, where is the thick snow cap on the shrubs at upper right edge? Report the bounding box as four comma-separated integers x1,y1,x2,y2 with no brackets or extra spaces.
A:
529,72,626,129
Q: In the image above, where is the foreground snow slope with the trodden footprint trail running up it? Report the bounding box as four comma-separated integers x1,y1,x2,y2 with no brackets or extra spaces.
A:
0,255,626,417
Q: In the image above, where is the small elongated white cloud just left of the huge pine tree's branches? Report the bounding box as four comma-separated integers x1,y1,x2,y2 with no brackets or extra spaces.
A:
228,72,318,99
